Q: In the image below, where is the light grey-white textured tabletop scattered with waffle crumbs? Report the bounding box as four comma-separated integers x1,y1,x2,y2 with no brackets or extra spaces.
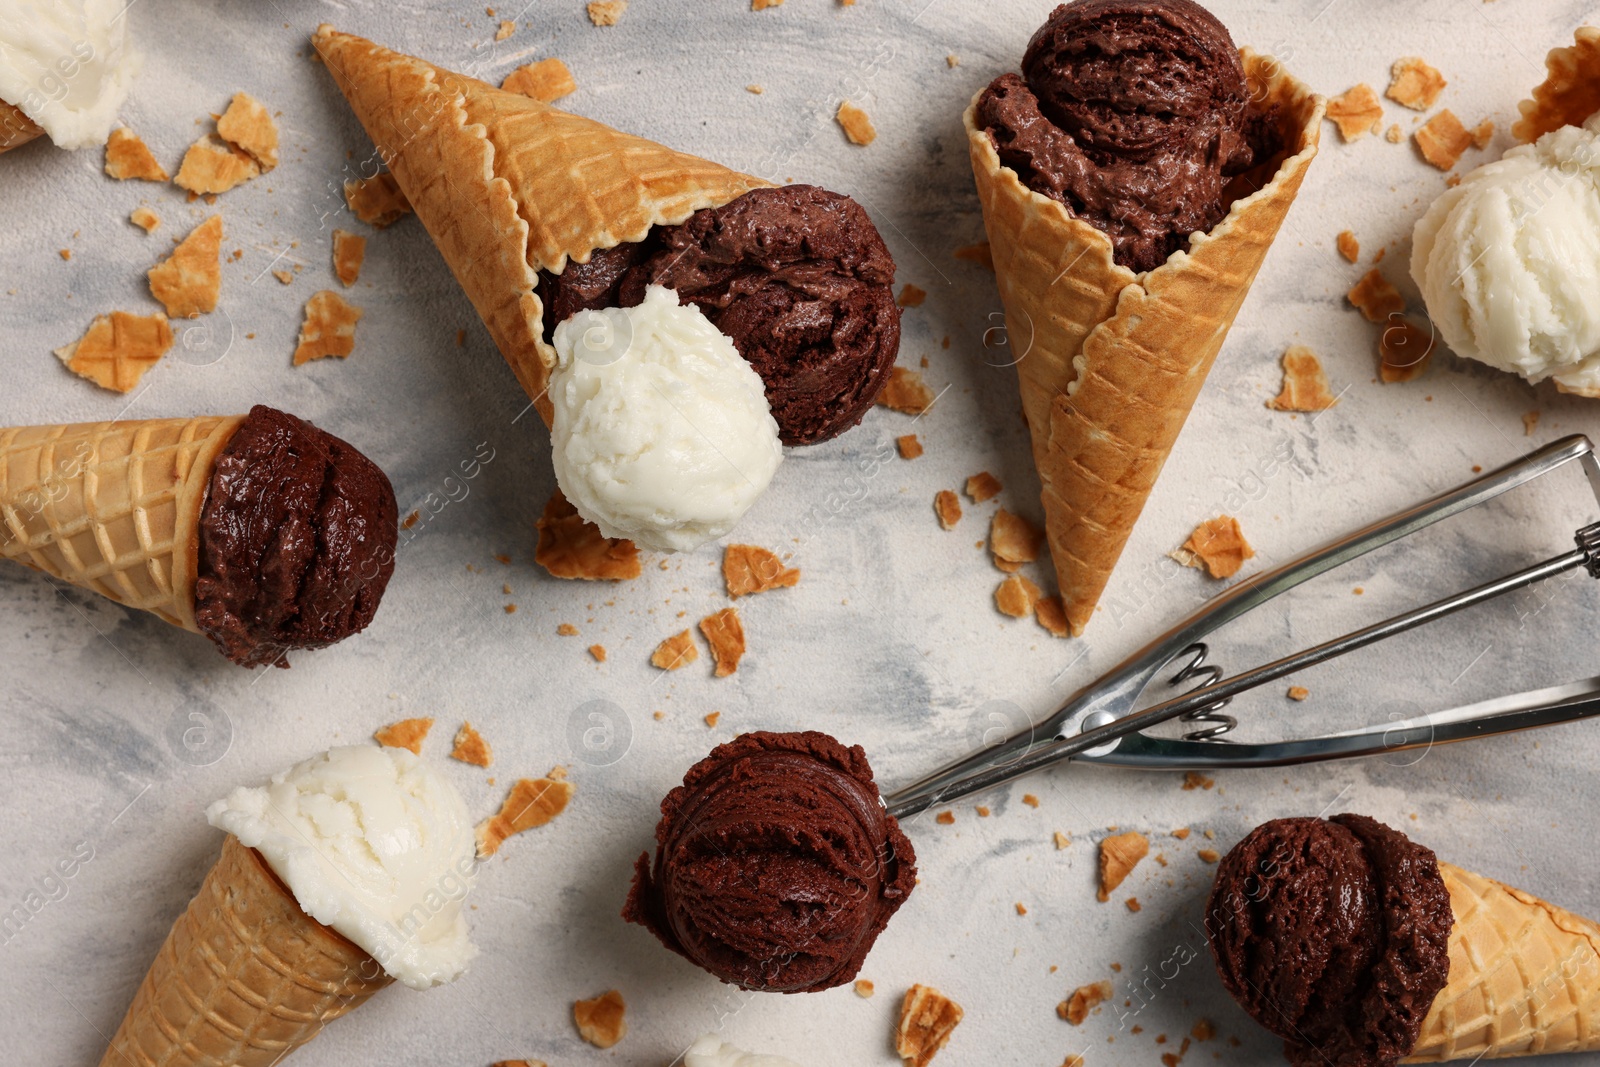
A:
0,0,1600,1067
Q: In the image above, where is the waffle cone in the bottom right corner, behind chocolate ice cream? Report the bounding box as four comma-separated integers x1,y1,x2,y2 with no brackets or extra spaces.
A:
1406,864,1600,1064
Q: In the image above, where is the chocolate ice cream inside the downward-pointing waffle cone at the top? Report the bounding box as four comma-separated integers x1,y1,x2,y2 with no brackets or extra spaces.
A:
976,0,1275,270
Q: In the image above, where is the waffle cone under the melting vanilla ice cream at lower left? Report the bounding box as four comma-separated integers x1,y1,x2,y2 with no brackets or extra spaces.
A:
101,837,394,1067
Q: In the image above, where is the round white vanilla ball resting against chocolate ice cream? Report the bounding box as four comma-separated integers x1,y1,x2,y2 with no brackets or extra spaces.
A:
550,285,782,552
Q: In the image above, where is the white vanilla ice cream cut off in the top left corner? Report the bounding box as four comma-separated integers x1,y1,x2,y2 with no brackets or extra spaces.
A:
0,0,139,149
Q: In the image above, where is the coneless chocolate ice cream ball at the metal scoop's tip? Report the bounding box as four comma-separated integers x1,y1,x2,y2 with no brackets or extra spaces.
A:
622,733,917,993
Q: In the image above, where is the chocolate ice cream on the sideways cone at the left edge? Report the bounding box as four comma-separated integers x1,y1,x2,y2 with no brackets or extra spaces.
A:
195,405,400,667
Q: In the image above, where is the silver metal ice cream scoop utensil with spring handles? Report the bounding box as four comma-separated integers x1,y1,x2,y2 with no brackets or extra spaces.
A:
885,434,1600,817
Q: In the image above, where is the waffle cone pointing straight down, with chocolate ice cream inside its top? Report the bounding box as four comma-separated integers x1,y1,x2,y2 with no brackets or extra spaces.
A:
965,56,1323,635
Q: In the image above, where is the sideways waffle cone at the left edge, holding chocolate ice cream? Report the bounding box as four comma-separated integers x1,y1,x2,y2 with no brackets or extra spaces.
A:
0,416,243,633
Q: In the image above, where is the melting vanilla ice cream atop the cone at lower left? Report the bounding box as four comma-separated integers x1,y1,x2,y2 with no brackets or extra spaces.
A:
205,744,477,989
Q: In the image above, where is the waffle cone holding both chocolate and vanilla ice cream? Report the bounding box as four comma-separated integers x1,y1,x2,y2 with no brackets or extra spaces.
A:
312,26,770,426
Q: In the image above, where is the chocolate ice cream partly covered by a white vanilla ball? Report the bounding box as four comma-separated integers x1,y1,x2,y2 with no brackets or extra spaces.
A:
539,186,899,445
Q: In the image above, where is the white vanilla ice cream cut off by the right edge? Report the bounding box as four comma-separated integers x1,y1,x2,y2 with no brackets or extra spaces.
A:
1411,115,1600,395
